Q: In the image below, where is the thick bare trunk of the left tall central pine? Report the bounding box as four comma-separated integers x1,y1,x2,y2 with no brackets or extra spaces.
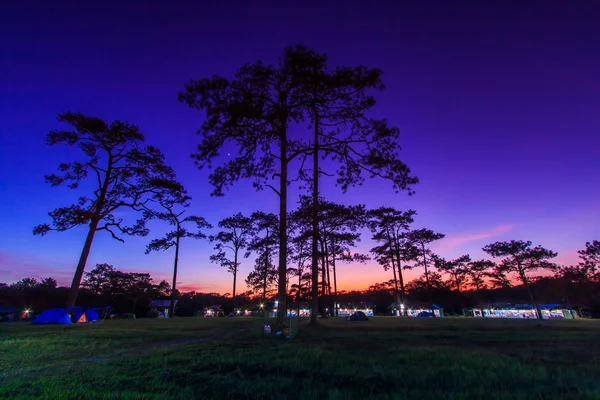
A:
277,124,288,325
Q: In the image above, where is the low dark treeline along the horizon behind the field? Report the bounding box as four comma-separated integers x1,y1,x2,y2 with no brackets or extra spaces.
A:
0,264,600,317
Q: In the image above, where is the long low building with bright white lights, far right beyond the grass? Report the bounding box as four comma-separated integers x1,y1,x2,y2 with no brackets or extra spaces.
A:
470,303,579,319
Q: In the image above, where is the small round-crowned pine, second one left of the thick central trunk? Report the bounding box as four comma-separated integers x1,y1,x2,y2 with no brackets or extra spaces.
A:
210,213,253,298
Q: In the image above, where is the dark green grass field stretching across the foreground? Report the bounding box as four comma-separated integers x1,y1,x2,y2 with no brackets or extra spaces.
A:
0,317,600,400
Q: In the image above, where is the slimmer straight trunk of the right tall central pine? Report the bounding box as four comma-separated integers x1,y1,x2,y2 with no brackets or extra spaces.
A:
310,113,319,325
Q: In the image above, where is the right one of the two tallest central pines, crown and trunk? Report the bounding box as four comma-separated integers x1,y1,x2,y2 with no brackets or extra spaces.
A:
299,54,417,325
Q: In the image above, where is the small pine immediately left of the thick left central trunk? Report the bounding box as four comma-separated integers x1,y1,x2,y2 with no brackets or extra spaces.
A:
246,211,279,300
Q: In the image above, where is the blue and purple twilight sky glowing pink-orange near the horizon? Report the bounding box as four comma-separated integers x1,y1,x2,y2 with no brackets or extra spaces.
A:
0,0,600,293
